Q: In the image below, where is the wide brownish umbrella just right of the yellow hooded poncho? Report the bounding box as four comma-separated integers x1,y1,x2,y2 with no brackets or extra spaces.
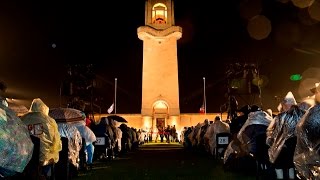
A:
49,108,85,122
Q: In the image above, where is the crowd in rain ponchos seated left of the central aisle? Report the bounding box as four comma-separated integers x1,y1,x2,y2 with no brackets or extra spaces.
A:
0,82,144,179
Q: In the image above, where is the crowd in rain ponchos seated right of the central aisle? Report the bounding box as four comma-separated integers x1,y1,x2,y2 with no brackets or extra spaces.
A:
181,84,320,179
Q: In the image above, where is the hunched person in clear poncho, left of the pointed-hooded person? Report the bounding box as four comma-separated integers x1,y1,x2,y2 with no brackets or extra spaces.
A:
237,105,272,155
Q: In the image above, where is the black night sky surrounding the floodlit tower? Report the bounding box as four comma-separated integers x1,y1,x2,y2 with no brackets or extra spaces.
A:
0,0,320,113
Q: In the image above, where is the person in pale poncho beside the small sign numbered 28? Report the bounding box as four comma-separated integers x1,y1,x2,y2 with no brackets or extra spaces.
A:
204,116,230,155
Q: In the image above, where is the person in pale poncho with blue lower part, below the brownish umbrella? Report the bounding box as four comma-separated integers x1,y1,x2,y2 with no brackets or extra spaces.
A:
68,116,97,168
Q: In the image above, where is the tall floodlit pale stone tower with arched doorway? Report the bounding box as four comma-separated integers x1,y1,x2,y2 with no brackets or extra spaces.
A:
137,0,182,132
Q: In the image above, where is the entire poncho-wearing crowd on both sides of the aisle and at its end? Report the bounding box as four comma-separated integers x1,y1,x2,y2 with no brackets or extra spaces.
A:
0,79,320,179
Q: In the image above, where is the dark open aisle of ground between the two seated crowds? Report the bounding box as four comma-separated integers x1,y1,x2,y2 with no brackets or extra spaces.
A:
75,144,255,180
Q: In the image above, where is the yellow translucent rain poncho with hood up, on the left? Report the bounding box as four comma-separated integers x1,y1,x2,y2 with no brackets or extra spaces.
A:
21,98,62,166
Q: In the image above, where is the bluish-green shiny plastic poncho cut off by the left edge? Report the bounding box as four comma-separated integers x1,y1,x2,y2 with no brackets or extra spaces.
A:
0,103,33,175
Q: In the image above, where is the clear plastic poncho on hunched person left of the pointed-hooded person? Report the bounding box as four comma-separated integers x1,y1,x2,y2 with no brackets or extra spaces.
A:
237,111,272,152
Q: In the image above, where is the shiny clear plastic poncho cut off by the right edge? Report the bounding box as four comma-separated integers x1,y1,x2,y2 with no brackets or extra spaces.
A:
293,104,320,179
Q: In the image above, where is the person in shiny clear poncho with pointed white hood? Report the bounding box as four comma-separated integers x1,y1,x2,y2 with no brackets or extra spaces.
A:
266,92,305,179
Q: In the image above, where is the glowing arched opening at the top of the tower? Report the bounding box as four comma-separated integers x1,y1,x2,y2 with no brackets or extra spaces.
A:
152,3,167,24
